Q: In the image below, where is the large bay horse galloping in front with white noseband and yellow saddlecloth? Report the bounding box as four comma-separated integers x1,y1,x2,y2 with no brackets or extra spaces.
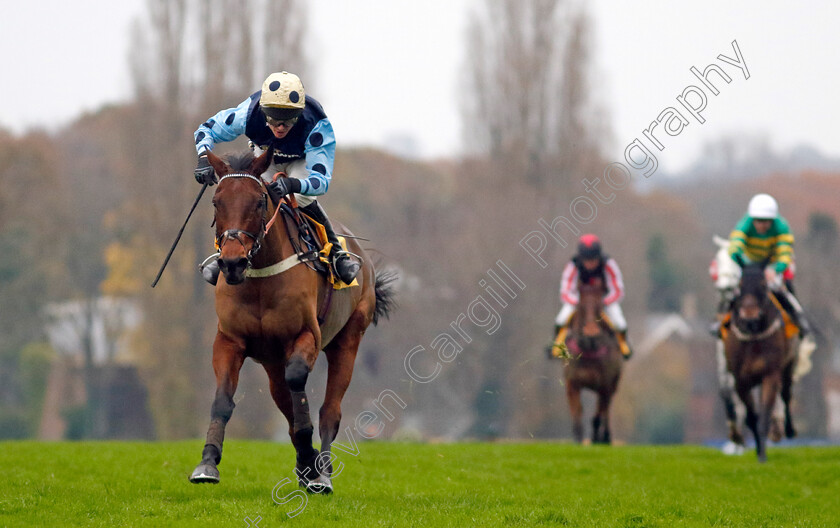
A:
190,149,395,493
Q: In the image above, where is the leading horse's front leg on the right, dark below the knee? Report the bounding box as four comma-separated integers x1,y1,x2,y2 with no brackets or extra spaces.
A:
285,330,319,491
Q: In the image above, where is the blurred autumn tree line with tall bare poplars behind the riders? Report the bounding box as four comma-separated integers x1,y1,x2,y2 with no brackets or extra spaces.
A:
0,0,840,441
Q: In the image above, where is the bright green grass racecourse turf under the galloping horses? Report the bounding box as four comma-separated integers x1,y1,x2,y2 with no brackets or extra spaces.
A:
0,439,840,528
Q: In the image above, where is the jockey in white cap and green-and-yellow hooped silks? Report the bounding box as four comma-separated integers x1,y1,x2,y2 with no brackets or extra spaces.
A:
727,194,811,338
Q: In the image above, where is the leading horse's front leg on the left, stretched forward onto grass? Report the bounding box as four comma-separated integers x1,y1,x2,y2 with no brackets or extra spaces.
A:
190,332,245,484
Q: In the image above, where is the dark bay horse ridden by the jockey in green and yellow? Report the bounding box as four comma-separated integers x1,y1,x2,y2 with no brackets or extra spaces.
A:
723,263,796,462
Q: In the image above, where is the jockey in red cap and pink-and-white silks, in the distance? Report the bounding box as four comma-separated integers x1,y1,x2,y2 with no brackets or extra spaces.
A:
552,234,633,359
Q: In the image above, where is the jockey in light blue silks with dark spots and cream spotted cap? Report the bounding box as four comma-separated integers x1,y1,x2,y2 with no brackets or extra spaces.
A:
195,71,359,284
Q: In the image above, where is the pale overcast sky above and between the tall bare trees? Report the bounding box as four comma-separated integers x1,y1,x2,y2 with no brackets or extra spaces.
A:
0,0,840,170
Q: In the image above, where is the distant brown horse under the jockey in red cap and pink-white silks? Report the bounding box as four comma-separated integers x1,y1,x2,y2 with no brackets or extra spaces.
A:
564,279,624,444
